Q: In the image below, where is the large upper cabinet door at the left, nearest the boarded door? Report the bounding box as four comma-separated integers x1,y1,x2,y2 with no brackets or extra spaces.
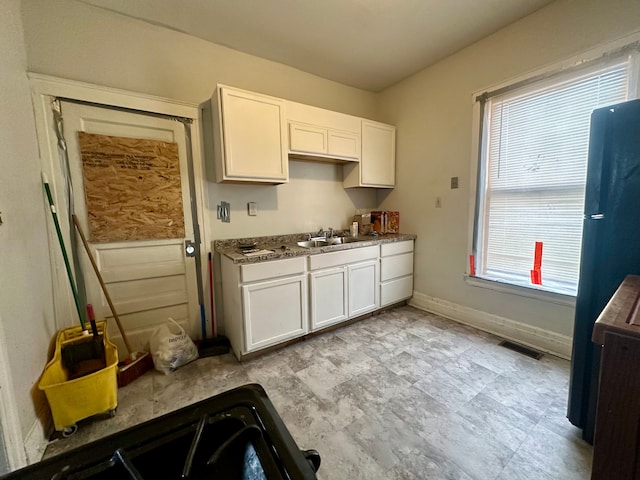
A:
217,87,289,183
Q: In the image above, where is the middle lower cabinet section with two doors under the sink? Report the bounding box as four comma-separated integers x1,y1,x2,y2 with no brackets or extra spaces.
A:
309,246,380,331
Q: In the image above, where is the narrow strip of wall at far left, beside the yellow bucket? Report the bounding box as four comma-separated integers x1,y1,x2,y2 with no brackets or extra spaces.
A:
0,0,55,467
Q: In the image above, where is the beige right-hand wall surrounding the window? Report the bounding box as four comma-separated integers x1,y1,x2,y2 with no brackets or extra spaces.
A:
379,0,640,335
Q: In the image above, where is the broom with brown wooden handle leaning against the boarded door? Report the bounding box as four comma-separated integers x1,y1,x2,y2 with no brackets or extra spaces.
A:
71,214,153,387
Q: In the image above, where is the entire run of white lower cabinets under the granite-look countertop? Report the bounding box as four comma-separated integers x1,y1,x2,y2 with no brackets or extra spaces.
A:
220,240,413,359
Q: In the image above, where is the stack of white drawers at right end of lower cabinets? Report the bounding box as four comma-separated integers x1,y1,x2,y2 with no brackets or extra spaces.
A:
380,240,413,307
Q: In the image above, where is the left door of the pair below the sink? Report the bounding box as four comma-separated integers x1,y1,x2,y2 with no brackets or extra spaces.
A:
309,267,349,331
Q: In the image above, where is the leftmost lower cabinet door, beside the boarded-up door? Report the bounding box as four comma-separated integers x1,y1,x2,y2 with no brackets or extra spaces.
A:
242,275,307,352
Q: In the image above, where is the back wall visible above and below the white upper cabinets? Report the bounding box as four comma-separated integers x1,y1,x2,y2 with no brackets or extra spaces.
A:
23,0,376,239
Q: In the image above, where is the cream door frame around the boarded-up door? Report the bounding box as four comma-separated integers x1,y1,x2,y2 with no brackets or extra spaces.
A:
27,73,211,336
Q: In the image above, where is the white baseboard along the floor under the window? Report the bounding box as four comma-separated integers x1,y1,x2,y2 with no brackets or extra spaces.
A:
409,292,572,360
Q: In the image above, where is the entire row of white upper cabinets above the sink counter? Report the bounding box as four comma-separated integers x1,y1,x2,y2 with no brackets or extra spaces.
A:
203,85,396,188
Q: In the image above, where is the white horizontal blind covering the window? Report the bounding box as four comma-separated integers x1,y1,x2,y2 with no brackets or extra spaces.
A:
475,60,630,295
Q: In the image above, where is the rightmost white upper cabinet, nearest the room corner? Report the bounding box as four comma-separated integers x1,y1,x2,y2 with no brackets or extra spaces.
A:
343,119,396,188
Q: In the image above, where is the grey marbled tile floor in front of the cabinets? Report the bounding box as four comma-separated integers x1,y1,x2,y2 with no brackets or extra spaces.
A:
45,306,592,480
